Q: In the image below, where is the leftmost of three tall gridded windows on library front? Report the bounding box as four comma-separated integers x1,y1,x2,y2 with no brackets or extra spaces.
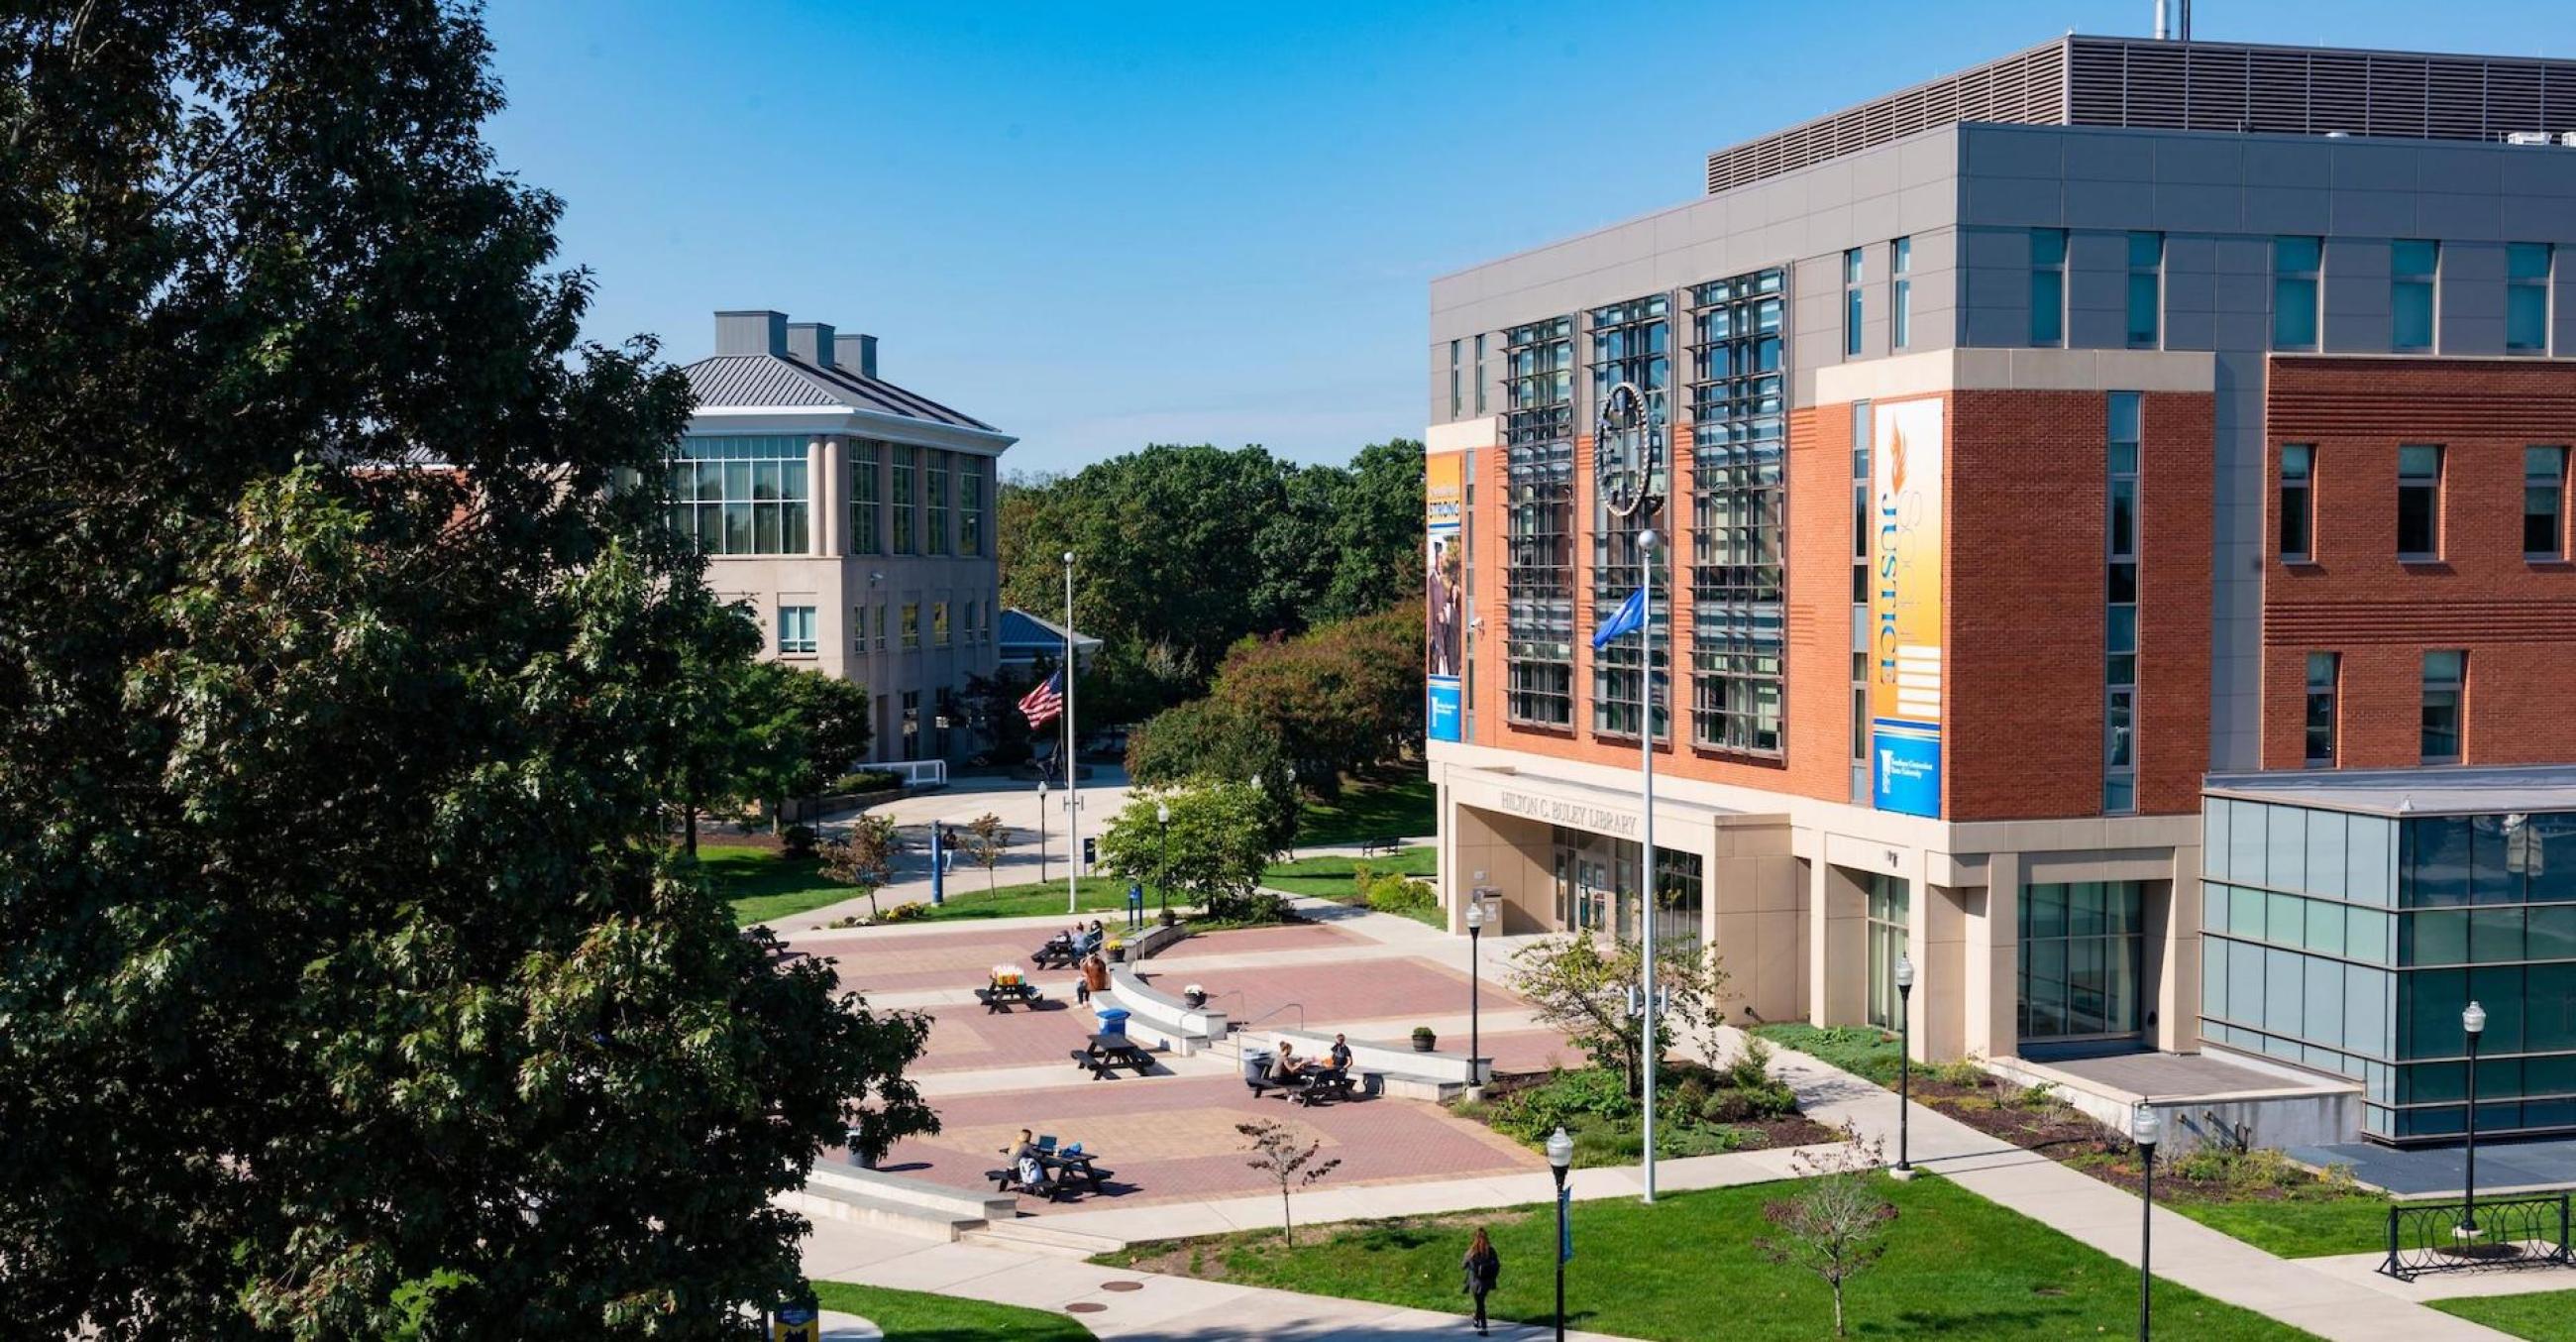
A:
1502,317,1574,727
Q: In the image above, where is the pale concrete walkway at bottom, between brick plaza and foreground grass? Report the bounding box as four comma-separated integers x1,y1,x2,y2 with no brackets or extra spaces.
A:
804,1221,1610,1342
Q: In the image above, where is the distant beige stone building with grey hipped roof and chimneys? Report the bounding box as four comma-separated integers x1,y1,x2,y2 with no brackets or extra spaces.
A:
673,311,1013,762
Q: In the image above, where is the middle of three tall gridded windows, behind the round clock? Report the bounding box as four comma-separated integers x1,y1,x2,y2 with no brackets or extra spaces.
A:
1587,293,1674,736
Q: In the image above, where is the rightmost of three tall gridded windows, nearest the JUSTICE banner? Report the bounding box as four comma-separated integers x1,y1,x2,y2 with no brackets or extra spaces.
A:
1690,271,1787,754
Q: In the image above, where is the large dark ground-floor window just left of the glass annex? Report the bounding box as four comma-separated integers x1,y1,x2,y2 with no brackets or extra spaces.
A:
2019,881,2146,1044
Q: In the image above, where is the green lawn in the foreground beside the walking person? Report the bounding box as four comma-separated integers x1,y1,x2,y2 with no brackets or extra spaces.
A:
1095,1174,2306,1342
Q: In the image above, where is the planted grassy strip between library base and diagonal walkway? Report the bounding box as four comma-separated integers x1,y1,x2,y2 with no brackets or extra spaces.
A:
1755,1023,2388,1257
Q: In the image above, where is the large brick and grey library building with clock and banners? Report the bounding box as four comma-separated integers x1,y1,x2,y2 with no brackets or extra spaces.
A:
1425,36,2576,1141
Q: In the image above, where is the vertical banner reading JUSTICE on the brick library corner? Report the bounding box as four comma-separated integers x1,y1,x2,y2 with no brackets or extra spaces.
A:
1871,399,1945,817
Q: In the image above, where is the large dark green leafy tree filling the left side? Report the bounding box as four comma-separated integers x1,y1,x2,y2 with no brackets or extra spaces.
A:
0,0,930,1339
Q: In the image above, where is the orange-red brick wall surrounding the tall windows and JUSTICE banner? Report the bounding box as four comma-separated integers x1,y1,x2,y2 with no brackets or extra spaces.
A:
1468,373,2210,822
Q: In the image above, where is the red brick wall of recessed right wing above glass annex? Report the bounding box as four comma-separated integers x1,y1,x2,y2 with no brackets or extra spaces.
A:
2262,356,2576,767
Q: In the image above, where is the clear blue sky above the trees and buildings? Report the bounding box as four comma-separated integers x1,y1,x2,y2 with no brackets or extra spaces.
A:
489,0,2576,472
